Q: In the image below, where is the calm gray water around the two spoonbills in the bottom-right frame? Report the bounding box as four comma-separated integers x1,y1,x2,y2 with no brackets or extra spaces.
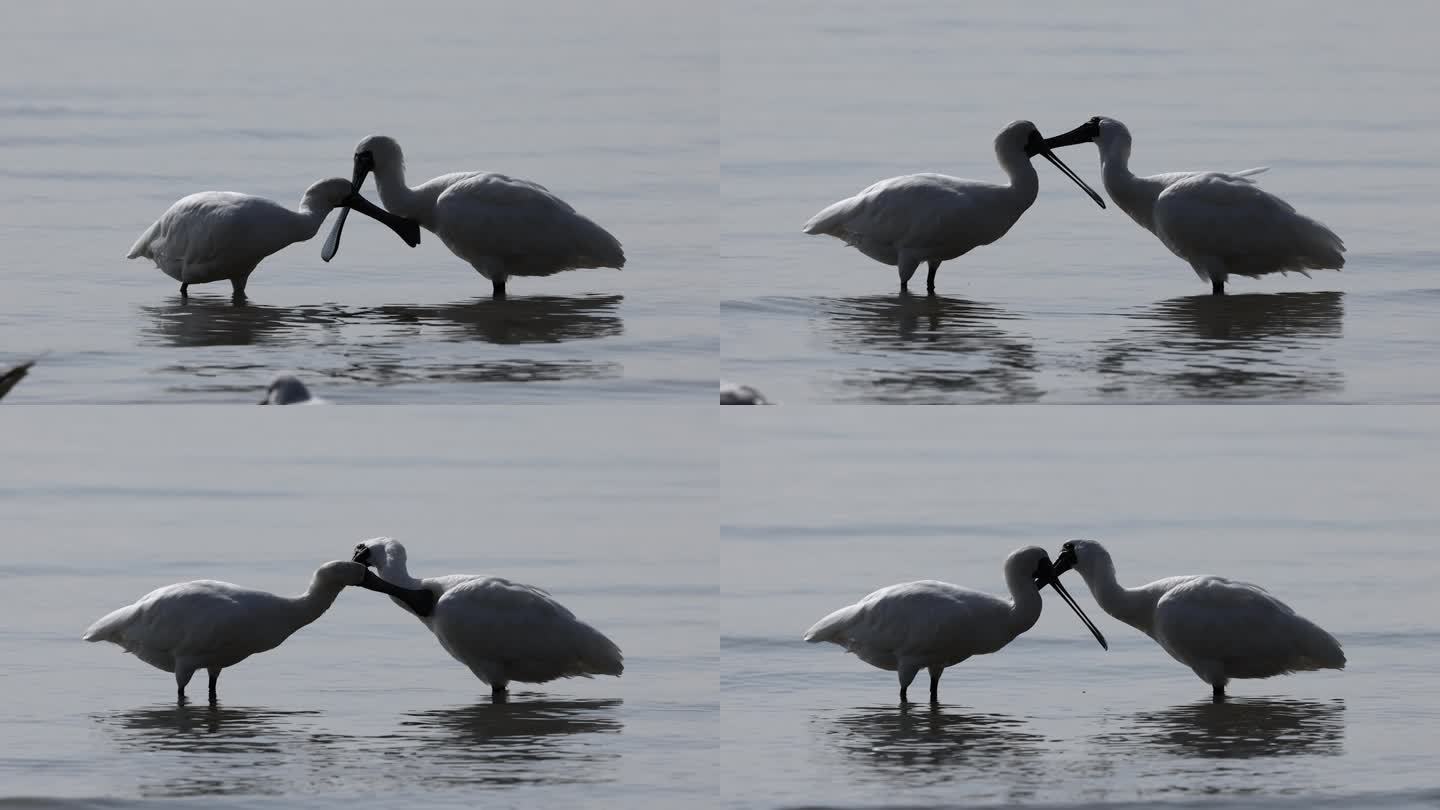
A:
720,408,1440,807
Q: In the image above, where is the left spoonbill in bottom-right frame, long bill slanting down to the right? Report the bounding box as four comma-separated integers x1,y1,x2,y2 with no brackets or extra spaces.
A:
805,546,1109,702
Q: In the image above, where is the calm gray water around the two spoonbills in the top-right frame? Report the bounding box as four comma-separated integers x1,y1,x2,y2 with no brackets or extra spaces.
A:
720,0,1440,404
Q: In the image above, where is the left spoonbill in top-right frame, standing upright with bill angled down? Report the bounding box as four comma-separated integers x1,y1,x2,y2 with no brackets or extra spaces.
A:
804,121,1104,293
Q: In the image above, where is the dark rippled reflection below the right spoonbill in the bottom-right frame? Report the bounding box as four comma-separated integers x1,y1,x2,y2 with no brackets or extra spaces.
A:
1099,699,1345,760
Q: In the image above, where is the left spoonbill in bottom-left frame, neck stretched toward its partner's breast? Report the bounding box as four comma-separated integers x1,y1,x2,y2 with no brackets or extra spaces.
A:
85,561,435,703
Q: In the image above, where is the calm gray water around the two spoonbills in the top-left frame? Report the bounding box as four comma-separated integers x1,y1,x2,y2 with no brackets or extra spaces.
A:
0,0,720,402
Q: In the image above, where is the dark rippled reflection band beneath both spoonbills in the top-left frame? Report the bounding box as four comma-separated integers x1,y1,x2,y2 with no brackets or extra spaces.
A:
140,295,624,347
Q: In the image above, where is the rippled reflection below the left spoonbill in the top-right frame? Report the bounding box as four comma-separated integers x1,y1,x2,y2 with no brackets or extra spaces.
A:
819,294,1044,404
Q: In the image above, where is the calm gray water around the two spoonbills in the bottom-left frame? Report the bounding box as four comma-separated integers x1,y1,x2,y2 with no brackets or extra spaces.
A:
0,408,719,809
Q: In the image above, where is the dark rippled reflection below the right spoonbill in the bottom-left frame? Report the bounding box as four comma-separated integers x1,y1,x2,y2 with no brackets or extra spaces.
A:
388,695,624,785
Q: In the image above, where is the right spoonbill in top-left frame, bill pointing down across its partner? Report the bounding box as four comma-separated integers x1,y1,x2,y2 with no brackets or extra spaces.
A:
329,135,625,298
